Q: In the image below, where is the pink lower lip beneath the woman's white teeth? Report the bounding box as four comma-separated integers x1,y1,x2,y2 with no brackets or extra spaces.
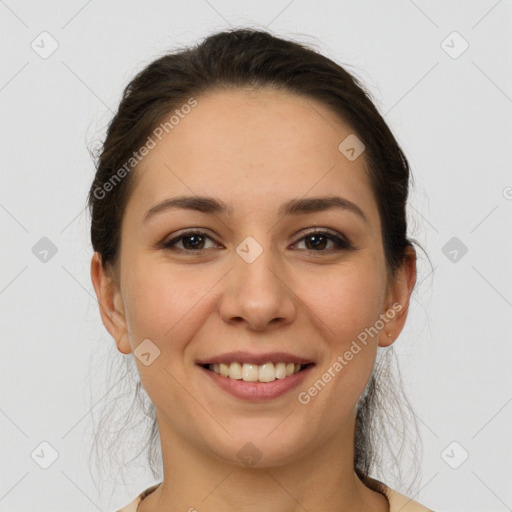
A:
199,365,314,401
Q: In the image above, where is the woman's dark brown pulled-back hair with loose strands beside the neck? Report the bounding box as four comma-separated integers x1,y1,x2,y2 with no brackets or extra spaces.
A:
88,29,428,496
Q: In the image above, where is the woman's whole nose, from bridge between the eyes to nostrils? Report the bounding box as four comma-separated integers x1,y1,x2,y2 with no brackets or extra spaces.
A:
220,235,295,330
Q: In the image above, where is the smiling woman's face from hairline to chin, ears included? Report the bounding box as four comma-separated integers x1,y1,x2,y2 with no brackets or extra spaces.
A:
92,86,411,465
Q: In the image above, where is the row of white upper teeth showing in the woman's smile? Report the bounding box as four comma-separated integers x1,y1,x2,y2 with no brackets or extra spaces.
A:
208,362,302,382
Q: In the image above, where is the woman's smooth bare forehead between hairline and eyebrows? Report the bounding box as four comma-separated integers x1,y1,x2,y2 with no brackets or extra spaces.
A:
124,89,377,228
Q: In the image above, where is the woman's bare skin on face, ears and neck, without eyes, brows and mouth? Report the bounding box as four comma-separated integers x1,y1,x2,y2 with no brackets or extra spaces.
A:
91,89,416,512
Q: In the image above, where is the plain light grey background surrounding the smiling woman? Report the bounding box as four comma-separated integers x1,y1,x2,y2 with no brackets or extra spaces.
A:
0,0,512,512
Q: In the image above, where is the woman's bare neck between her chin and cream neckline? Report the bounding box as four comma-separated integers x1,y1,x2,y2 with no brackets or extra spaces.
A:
137,414,389,512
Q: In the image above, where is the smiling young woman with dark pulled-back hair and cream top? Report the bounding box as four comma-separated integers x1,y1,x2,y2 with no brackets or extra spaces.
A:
89,29,434,512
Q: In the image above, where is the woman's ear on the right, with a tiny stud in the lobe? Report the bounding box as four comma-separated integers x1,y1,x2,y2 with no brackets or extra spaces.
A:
379,246,416,347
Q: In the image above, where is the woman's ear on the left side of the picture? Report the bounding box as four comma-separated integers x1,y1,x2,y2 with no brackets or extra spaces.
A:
91,252,132,354
